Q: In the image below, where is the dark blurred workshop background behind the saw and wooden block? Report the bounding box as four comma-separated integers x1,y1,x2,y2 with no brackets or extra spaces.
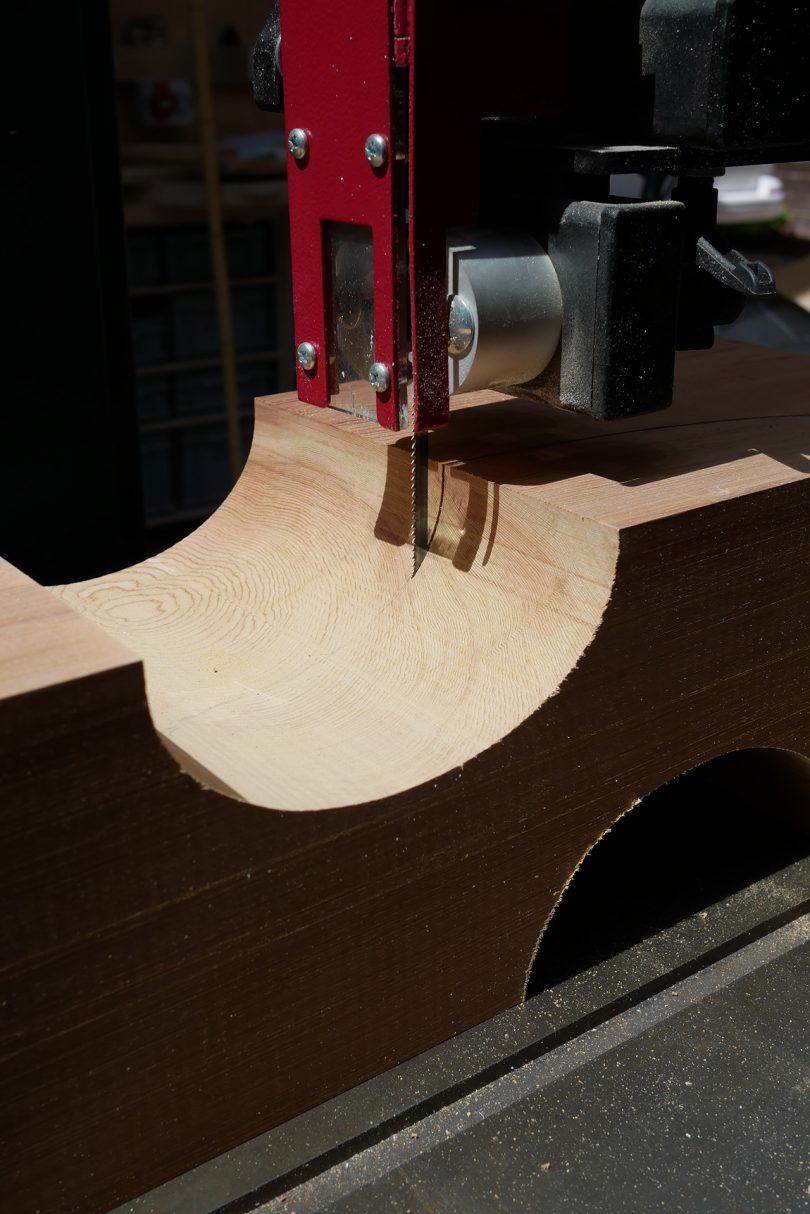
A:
0,0,810,583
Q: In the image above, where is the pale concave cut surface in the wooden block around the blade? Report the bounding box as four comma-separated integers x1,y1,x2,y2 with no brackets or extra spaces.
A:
53,383,618,810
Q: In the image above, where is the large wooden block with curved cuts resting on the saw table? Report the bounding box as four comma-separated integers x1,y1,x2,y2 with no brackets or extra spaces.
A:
0,345,810,1214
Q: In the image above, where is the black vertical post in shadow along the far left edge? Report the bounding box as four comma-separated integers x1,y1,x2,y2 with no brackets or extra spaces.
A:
0,0,143,583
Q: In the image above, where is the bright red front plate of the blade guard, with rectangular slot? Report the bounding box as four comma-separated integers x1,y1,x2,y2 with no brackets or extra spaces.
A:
281,0,400,430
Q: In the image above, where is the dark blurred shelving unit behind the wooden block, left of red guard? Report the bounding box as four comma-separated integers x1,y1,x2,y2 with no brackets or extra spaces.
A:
128,216,295,551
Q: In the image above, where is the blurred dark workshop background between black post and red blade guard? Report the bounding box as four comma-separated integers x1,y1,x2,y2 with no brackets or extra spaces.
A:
111,0,295,550
